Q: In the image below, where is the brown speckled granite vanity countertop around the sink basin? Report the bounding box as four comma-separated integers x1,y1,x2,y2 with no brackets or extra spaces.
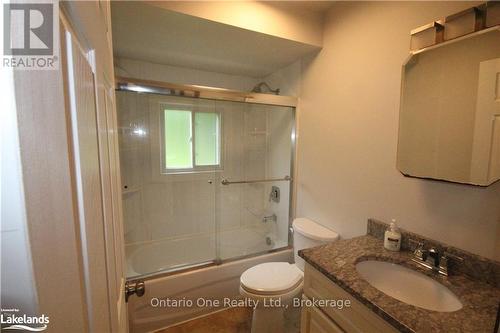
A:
299,235,500,333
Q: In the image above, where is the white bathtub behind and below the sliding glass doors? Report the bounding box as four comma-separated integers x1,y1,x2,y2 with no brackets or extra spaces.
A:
127,229,293,333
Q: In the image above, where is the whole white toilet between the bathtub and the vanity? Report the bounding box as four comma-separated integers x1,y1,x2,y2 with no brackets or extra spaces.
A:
240,218,339,333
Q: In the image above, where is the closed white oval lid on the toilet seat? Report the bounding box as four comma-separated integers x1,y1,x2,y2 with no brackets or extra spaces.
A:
240,262,303,294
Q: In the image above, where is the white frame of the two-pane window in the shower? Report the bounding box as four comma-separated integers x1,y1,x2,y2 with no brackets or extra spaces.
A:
160,102,224,175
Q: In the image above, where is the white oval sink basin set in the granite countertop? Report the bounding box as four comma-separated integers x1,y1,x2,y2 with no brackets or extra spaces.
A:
356,260,462,312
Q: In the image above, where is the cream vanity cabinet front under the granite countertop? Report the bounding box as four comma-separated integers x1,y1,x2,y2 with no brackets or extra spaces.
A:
301,264,398,333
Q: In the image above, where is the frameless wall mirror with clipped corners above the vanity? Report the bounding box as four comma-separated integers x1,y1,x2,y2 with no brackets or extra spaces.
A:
397,27,500,186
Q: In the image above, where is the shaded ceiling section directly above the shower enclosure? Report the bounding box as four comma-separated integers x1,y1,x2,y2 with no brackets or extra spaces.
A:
112,1,325,77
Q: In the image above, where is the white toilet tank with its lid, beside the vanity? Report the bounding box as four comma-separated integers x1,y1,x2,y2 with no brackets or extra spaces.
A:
292,217,339,271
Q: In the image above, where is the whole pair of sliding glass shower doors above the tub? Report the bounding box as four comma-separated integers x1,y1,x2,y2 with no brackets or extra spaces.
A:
116,91,295,277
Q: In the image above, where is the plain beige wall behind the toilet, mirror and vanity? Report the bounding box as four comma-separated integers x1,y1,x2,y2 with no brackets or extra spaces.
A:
297,2,500,259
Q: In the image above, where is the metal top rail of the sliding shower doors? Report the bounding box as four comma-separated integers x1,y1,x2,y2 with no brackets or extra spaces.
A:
115,76,297,107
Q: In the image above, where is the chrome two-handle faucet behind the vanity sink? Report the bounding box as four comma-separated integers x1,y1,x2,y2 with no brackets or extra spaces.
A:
409,239,464,276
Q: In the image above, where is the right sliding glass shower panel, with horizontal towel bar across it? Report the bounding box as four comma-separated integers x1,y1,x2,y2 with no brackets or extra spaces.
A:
216,101,294,260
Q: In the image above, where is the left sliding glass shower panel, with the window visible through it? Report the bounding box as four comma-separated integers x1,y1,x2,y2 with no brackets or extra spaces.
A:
117,91,221,277
